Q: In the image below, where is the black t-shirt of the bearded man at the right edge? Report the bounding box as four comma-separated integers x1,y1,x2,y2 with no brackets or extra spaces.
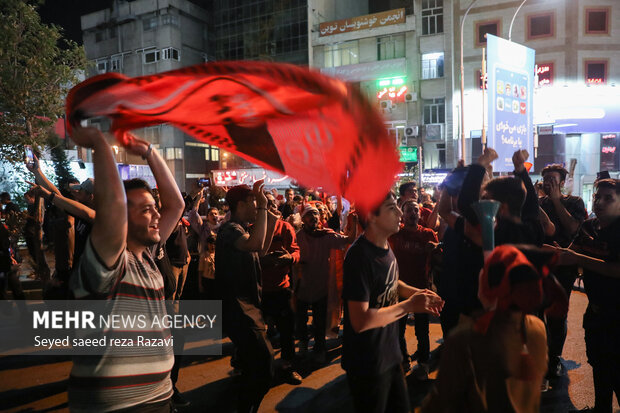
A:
575,218,620,318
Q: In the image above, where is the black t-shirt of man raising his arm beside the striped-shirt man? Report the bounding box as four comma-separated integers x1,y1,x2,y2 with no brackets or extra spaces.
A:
215,221,265,330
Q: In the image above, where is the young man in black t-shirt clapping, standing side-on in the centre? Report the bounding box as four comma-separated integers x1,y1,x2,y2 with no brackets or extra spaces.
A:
342,194,443,412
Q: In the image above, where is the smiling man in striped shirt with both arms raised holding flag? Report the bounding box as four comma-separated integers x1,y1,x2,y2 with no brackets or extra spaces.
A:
69,126,184,412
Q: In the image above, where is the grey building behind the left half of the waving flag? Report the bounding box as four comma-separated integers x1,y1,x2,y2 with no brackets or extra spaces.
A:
81,0,220,191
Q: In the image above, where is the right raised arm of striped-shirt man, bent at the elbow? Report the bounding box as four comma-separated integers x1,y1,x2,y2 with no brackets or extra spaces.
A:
126,137,185,241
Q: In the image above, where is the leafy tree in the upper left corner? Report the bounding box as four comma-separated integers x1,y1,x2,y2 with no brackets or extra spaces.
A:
0,0,87,162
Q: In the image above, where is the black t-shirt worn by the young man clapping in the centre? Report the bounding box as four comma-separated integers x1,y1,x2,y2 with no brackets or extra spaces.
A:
342,236,402,376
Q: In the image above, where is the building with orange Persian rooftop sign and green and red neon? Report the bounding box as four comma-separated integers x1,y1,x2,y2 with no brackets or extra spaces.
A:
309,0,455,169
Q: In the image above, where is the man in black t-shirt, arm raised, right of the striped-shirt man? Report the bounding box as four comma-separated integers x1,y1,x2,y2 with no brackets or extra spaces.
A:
215,180,277,412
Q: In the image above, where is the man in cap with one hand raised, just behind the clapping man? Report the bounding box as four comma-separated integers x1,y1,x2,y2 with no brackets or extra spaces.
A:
295,204,357,363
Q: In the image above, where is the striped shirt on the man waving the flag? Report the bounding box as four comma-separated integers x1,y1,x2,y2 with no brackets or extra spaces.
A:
69,238,174,412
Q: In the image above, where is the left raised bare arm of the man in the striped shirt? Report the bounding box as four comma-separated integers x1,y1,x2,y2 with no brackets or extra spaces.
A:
72,126,127,267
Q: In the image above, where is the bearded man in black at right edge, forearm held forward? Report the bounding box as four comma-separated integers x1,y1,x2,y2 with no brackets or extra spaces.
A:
558,179,620,413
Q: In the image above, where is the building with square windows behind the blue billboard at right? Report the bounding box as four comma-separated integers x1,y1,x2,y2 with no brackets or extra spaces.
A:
450,0,620,206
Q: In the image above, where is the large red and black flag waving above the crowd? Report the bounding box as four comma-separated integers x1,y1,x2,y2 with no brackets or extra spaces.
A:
67,62,401,210
